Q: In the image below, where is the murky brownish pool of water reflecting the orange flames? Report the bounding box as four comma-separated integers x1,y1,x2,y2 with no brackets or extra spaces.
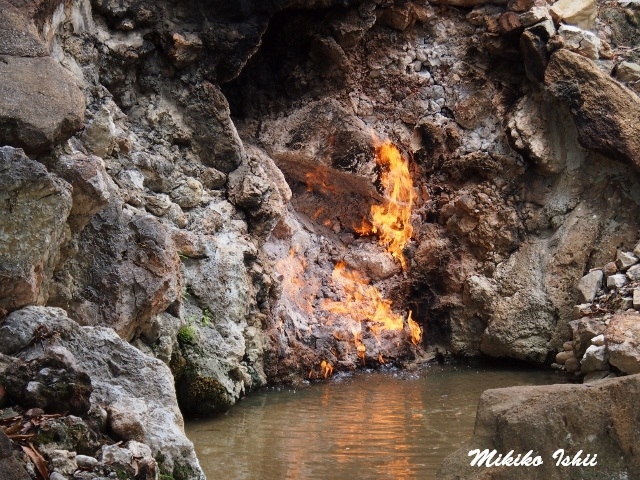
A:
186,365,565,480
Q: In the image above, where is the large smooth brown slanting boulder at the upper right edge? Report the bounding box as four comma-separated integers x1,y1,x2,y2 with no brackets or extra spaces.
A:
545,49,640,170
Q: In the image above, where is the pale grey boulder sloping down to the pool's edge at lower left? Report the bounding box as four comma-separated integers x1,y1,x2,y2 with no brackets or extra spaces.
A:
0,307,204,480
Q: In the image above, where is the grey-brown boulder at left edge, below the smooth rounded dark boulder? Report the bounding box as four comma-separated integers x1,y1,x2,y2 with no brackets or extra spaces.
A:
0,146,72,311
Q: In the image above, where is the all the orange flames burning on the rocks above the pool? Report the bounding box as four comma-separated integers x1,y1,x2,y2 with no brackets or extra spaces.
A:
277,142,423,378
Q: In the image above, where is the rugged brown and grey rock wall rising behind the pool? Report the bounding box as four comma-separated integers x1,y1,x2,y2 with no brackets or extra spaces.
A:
0,0,640,468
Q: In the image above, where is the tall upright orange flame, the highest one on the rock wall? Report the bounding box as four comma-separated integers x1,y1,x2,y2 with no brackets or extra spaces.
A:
358,142,415,270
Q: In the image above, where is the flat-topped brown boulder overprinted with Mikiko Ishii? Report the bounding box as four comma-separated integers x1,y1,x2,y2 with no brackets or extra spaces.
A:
438,375,640,480
